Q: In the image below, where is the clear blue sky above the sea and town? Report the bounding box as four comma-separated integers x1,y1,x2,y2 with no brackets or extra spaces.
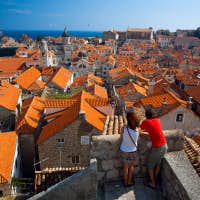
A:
0,0,200,31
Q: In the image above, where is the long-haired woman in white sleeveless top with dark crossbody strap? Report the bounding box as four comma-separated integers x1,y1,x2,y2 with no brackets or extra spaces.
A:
120,112,140,186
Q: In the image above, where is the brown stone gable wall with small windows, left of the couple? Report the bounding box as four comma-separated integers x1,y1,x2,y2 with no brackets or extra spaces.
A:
38,114,100,170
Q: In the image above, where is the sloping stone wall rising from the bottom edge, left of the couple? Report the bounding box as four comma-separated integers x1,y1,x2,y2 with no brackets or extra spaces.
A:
29,159,97,200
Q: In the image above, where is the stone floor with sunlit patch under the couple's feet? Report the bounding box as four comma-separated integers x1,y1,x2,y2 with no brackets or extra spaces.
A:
104,178,164,200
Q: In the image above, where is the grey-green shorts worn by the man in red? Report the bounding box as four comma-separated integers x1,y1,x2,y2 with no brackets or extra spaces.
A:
147,144,168,169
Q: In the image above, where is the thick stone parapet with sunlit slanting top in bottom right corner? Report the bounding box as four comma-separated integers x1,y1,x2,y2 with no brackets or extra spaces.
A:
161,151,200,200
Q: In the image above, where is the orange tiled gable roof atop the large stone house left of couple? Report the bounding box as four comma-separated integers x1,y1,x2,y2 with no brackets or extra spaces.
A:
37,91,108,144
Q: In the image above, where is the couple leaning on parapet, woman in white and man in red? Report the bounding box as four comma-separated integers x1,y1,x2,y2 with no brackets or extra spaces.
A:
120,109,167,189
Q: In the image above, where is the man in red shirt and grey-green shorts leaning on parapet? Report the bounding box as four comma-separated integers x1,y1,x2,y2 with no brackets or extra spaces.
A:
140,109,167,188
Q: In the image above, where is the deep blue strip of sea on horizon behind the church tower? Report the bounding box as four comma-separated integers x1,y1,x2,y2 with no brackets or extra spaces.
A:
0,30,103,40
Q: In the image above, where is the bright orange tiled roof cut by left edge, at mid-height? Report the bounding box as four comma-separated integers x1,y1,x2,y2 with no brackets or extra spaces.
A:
0,80,21,111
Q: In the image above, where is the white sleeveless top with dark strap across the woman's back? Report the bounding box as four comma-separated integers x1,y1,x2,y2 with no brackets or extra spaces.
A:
120,126,139,152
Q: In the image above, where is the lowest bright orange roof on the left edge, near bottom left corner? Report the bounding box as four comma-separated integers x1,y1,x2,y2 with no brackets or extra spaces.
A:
0,131,17,182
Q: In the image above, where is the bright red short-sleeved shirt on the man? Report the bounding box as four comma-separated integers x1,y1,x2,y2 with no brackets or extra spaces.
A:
140,118,167,147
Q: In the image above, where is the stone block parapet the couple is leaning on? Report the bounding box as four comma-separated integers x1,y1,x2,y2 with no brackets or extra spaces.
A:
90,129,184,184
